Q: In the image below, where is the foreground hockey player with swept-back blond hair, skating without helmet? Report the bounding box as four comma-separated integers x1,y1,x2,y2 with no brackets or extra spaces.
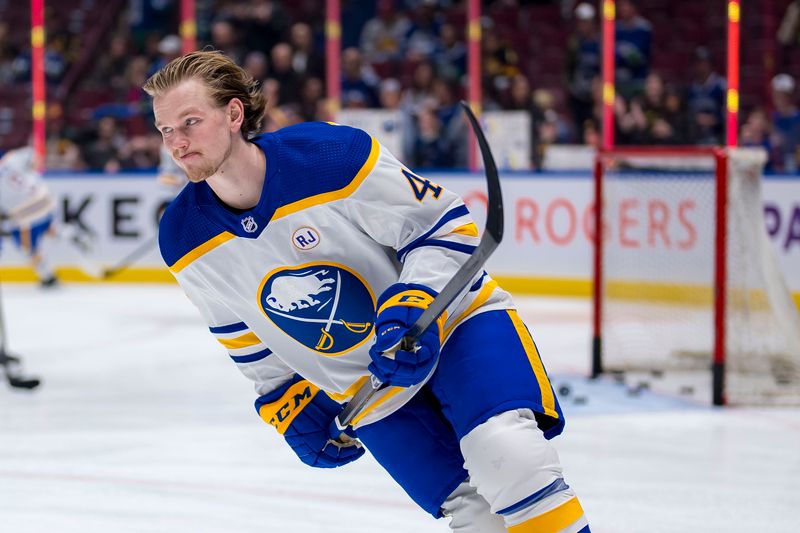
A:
144,51,589,533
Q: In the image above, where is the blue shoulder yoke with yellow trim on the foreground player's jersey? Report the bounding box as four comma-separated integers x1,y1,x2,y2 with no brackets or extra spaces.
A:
159,122,379,272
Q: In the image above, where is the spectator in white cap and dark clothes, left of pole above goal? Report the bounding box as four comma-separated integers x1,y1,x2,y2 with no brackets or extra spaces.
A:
565,2,600,139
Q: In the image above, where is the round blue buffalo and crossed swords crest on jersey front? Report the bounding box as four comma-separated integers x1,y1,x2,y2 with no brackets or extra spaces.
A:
258,263,375,355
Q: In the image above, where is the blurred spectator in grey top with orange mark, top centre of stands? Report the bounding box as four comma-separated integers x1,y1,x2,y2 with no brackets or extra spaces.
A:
359,0,411,63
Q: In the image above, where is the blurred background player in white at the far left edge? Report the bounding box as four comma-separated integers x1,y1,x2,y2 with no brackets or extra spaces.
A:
0,147,96,287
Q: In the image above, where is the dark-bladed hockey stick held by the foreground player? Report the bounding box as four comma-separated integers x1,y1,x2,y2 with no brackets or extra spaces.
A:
336,100,503,432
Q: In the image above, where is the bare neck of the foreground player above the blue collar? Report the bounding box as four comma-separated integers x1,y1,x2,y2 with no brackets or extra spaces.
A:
207,139,266,209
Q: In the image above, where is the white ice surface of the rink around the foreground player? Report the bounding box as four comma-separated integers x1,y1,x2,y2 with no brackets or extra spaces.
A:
0,284,800,533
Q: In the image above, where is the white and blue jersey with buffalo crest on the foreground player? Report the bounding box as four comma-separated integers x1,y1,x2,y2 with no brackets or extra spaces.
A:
159,123,512,426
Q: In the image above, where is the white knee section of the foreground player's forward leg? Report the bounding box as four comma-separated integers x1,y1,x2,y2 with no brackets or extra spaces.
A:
461,409,574,522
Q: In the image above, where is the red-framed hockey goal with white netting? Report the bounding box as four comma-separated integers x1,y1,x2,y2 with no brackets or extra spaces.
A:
592,147,800,405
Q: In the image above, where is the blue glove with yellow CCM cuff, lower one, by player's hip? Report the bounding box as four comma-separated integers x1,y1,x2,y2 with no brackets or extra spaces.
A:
256,375,364,468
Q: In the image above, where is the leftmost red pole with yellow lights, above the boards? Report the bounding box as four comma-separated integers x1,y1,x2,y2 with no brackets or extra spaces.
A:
31,0,47,171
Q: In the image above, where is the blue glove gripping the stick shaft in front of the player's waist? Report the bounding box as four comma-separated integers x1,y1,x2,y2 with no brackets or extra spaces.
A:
369,283,445,387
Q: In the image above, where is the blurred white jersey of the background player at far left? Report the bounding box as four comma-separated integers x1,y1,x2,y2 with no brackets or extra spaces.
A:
0,147,55,228
